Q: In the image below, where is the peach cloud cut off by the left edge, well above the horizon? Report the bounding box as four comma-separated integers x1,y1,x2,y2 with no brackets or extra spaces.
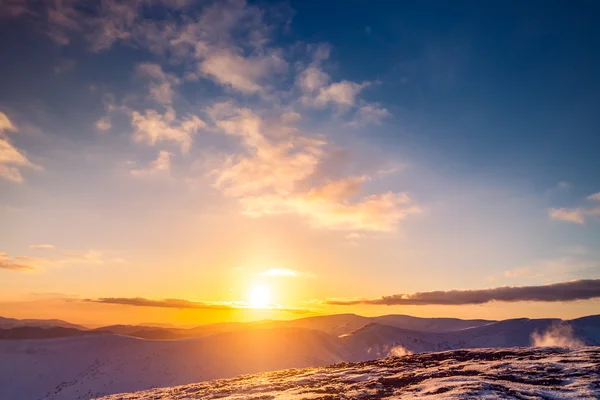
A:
0,112,41,183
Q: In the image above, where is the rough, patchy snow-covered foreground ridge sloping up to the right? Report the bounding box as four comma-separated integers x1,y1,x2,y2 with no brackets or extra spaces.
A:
102,347,600,400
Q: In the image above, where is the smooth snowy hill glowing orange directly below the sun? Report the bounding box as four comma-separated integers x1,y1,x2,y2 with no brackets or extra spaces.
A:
0,328,350,400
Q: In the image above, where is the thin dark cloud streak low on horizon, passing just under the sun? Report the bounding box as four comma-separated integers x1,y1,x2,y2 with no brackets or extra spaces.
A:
84,297,311,314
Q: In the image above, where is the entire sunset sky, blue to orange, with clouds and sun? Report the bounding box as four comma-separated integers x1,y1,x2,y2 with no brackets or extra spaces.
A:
0,0,600,324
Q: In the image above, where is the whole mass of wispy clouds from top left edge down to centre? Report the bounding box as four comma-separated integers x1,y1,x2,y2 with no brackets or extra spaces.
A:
3,0,421,232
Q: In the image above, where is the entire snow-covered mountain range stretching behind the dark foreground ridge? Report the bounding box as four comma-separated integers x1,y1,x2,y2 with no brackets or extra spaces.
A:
0,314,600,400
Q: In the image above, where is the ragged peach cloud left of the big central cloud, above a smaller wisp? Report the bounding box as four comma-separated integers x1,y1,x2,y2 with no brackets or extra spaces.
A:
131,108,206,152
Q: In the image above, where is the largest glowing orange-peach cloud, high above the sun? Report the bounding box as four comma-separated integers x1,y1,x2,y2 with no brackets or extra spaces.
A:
207,103,421,232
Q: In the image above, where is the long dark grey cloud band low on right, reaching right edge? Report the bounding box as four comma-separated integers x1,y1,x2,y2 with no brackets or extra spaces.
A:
325,279,600,306
